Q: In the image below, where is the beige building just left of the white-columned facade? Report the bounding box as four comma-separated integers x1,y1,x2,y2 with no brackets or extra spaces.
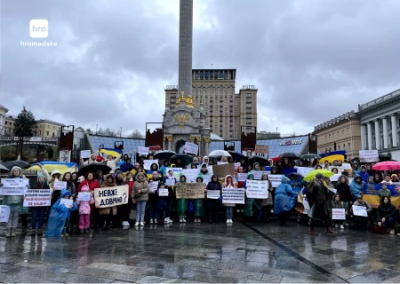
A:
314,111,361,159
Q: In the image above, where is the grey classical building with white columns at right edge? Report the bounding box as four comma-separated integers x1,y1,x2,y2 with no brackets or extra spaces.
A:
358,89,400,160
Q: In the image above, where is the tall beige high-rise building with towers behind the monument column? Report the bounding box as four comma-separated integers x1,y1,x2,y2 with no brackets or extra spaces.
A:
165,69,257,140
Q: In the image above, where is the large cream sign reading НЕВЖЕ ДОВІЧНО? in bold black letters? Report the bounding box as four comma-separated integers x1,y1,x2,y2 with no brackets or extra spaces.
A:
94,185,129,208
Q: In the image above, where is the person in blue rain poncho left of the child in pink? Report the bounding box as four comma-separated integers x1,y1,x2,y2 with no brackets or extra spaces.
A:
45,189,78,237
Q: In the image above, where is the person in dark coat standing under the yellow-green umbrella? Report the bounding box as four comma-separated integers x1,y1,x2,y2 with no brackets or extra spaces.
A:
307,173,335,235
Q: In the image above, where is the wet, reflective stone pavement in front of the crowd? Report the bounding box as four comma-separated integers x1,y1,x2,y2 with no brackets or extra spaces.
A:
0,222,400,283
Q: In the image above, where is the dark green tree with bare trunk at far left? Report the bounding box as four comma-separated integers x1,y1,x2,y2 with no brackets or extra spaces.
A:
15,106,36,160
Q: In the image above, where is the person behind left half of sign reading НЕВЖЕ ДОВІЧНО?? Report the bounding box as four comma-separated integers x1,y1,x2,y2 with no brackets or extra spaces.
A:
98,174,118,231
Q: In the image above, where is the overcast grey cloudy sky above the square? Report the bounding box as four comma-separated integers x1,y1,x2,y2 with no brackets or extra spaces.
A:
0,0,400,135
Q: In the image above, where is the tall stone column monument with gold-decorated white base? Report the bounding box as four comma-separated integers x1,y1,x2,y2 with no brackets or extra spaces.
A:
163,0,210,156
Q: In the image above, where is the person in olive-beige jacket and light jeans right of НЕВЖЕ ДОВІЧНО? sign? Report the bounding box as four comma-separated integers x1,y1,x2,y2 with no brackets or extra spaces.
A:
132,173,149,227
